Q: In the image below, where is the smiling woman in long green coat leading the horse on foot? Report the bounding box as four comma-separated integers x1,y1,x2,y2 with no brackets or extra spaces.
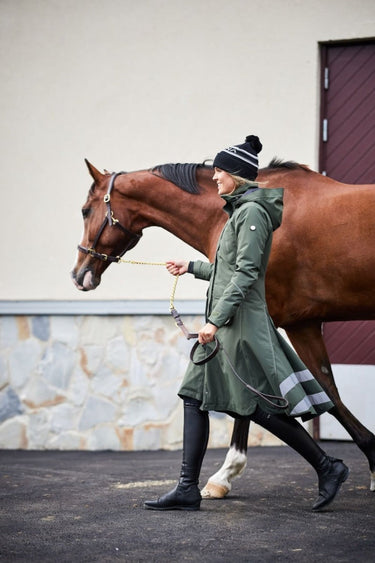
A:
145,135,349,510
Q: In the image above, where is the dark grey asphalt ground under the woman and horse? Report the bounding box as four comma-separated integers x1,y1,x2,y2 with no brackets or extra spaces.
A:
0,442,375,563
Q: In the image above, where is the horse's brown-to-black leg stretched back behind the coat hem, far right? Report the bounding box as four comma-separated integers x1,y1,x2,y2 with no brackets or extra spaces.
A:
285,322,375,491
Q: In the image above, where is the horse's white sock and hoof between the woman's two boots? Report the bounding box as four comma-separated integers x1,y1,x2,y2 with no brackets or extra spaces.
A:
201,447,247,499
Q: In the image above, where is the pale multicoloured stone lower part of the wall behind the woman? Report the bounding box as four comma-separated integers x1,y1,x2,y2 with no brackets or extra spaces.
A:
0,315,279,450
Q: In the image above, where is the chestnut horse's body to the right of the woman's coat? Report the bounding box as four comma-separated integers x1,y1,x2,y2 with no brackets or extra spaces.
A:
267,183,375,324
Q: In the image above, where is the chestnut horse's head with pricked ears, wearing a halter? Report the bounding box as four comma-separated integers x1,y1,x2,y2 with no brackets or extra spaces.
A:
72,160,142,291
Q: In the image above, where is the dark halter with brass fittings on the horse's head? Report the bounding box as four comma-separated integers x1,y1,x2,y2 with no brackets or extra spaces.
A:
77,172,142,262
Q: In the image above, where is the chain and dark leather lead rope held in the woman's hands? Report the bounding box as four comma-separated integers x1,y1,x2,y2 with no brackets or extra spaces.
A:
119,258,289,410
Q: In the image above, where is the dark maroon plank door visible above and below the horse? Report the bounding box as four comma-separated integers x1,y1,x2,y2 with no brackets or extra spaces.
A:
319,41,375,365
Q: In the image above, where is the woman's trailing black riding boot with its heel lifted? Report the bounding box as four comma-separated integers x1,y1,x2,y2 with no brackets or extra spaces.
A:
251,407,349,510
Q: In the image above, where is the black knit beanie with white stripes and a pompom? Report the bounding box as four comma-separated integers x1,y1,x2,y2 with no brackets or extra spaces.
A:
213,135,262,180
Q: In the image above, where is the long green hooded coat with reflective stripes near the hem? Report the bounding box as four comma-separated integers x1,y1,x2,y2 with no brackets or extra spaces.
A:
178,183,333,420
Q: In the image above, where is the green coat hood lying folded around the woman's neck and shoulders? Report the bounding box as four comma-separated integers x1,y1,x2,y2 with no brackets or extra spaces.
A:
221,182,284,230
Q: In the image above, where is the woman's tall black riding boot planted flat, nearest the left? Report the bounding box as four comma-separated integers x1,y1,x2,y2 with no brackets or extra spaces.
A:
145,397,209,510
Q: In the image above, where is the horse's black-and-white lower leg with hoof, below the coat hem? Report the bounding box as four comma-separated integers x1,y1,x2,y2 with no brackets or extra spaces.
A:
201,418,250,499
